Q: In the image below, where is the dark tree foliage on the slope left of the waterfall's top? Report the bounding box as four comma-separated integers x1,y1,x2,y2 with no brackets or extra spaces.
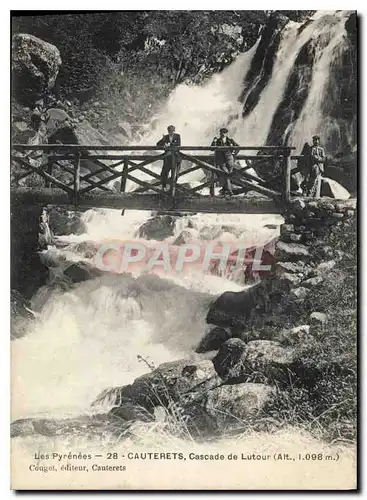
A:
12,11,266,97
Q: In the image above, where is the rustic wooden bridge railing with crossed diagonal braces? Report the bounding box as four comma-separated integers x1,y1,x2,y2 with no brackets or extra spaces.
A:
11,144,300,205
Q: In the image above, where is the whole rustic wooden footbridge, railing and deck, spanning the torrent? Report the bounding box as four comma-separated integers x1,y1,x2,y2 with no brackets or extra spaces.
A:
11,144,300,213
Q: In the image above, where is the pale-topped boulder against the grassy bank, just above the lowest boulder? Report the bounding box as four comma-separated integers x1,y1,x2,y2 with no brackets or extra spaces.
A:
213,339,294,383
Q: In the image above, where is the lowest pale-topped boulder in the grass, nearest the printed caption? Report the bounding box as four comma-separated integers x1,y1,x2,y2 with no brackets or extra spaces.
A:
183,383,276,436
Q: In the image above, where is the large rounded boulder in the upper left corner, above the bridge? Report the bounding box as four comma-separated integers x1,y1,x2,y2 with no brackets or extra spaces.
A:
12,33,61,104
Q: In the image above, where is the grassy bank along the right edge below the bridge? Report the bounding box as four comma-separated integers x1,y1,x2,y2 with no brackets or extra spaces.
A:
269,219,357,442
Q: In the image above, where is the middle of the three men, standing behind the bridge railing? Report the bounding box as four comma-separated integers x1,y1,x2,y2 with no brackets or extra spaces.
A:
211,128,239,195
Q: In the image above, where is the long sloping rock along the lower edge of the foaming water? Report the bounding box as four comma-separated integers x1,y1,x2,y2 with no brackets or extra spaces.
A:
93,360,222,411
